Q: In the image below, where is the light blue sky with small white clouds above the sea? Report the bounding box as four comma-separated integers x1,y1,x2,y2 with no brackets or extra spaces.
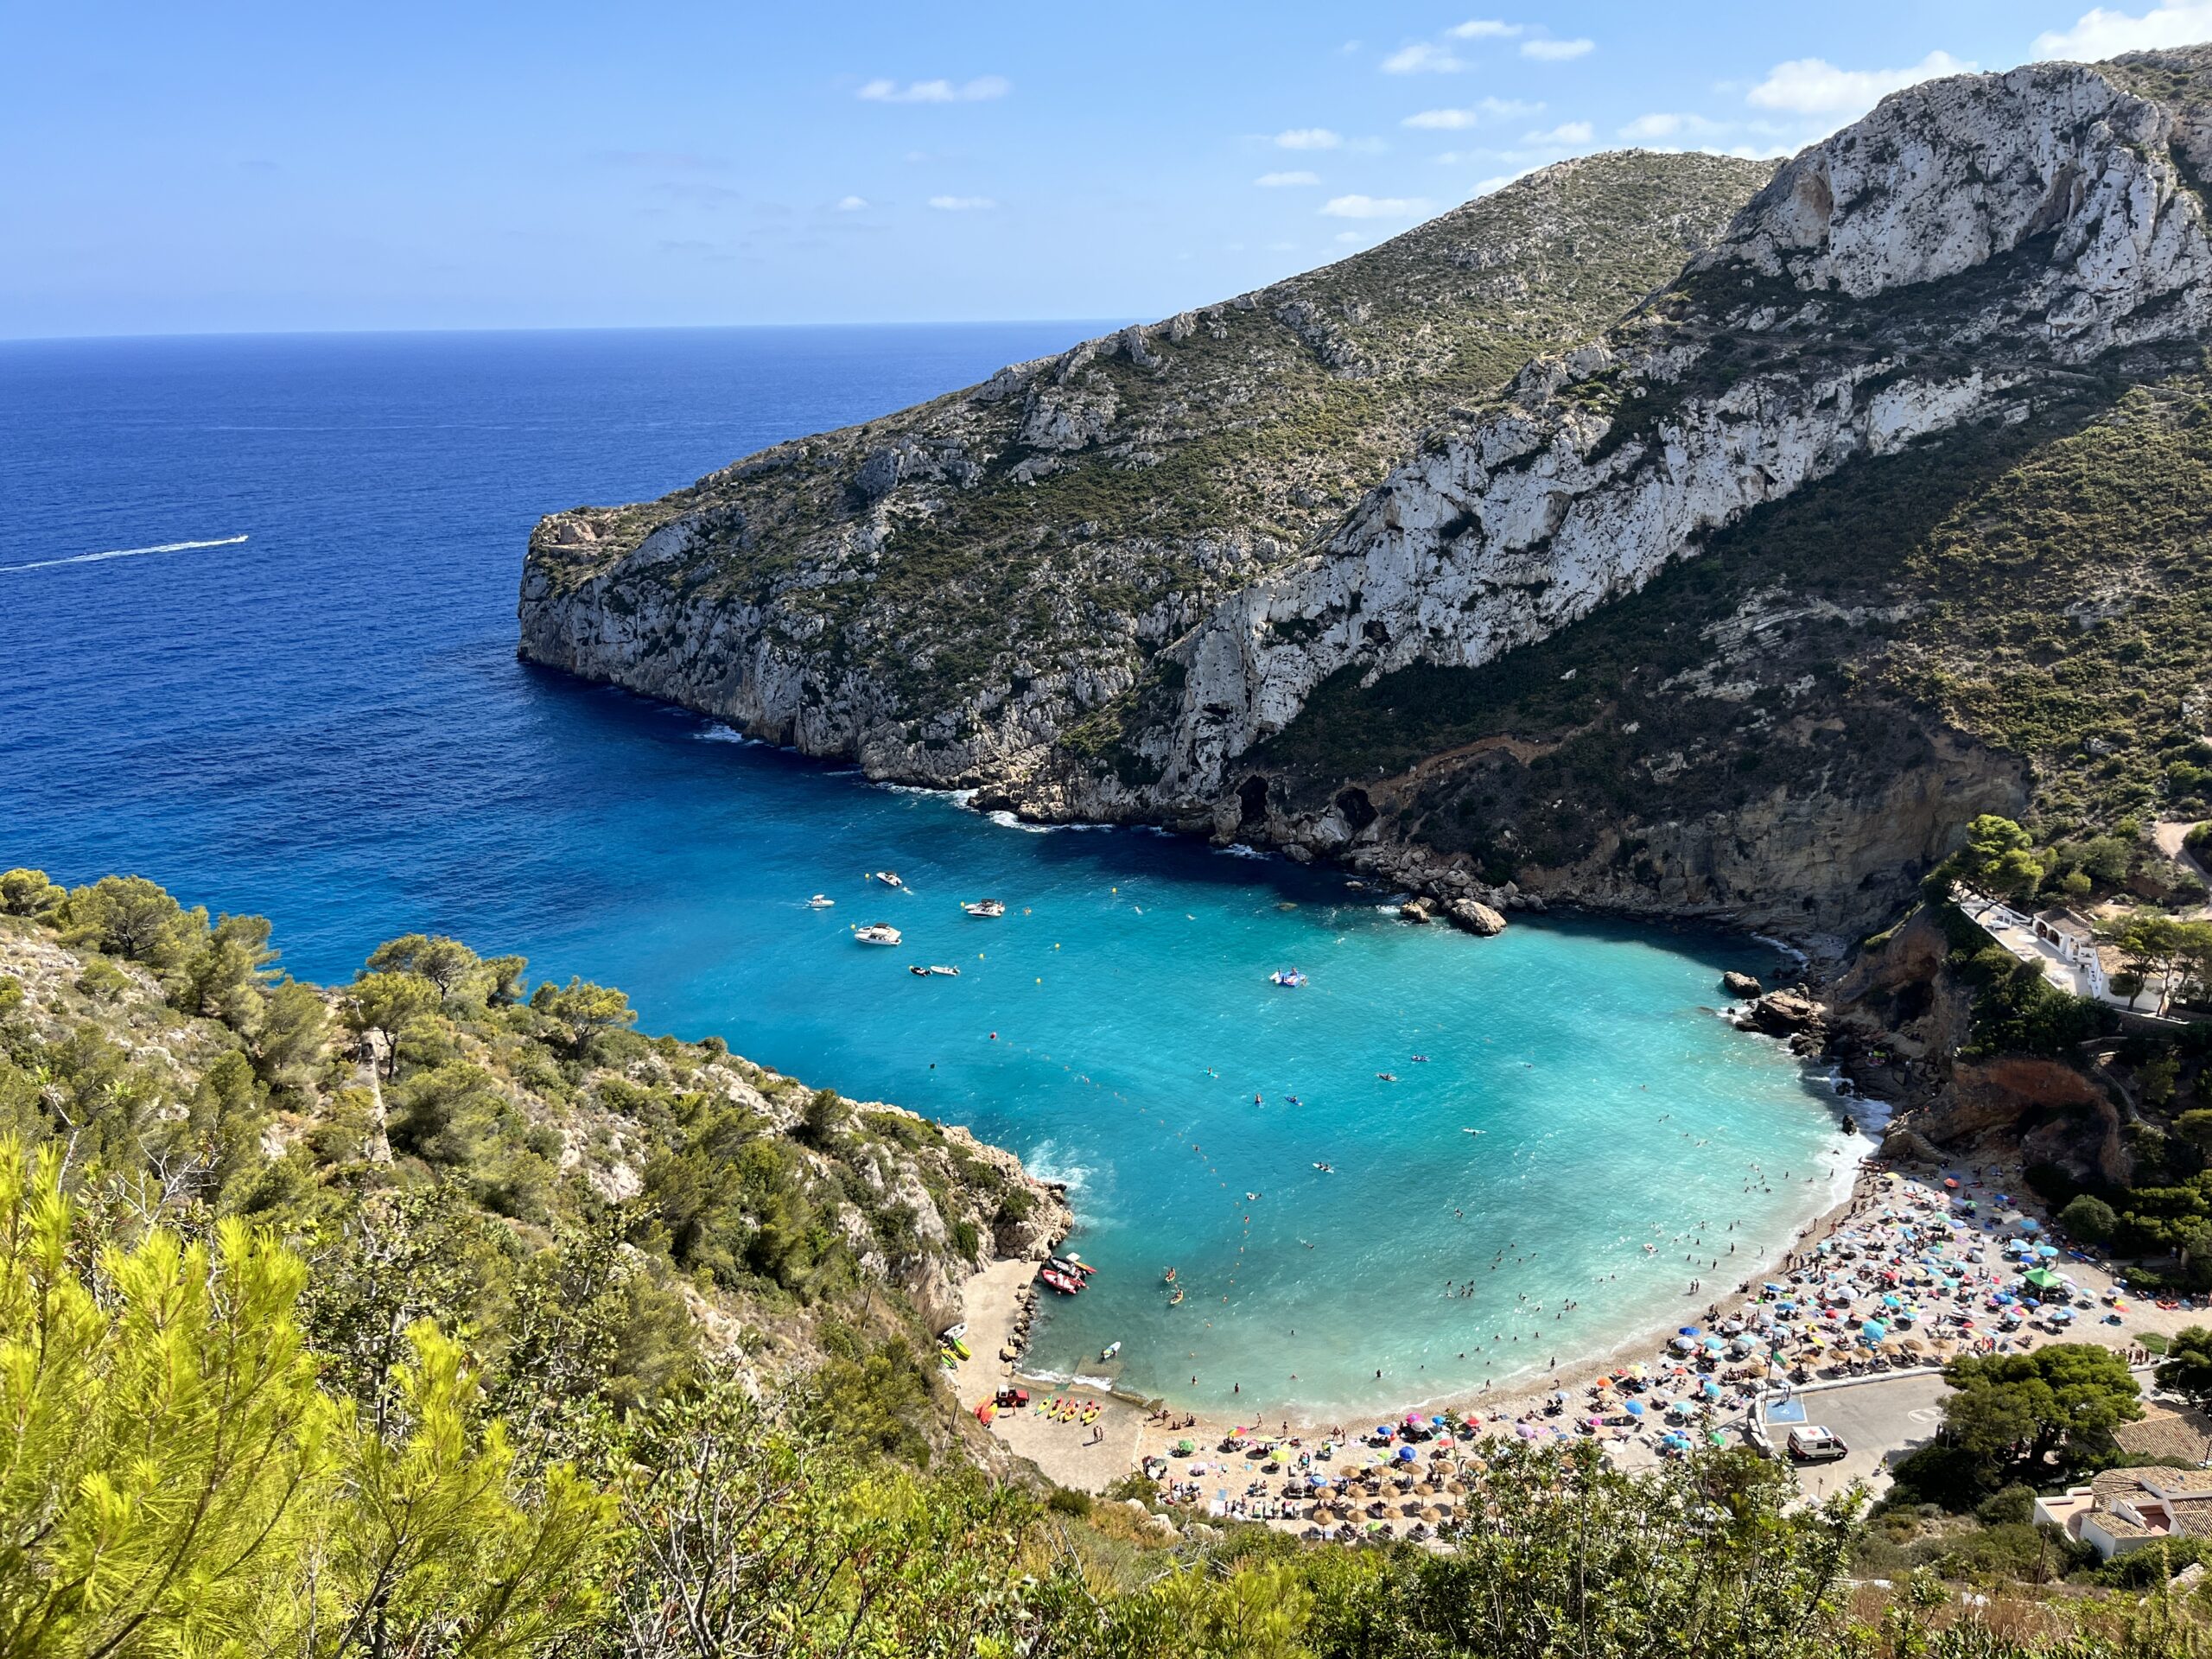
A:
13,0,2212,339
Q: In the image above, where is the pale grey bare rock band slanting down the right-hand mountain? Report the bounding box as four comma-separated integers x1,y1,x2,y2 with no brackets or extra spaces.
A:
1159,64,2212,797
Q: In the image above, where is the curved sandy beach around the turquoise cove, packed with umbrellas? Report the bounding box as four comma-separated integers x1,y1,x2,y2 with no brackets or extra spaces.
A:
953,1161,2205,1531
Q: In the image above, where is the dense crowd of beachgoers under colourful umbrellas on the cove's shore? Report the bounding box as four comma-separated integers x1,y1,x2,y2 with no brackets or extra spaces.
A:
969,1164,2195,1537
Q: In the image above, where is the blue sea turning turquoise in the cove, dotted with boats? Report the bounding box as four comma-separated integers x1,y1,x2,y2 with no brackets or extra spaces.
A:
0,323,1845,1411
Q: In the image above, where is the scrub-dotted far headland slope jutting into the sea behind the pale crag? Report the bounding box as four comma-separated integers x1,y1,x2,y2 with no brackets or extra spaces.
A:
520,153,1772,783
